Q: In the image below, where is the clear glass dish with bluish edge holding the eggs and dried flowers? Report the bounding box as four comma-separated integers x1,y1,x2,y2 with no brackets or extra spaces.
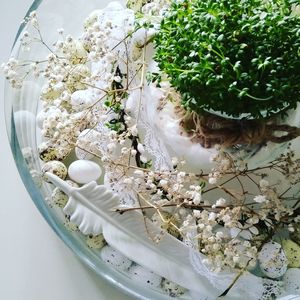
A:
5,0,180,299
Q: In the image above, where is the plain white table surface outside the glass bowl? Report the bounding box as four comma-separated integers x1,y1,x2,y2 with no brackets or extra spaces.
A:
0,0,132,300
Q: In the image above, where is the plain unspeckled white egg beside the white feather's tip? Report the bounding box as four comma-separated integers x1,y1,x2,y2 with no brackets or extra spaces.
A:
68,159,102,184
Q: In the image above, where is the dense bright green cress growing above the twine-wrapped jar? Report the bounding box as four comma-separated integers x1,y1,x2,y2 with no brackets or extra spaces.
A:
154,0,300,119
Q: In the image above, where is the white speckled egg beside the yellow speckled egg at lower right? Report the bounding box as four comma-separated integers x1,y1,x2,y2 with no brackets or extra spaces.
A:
258,241,288,279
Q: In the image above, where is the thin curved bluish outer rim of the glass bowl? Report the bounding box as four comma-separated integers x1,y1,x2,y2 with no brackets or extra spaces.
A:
4,0,176,300
